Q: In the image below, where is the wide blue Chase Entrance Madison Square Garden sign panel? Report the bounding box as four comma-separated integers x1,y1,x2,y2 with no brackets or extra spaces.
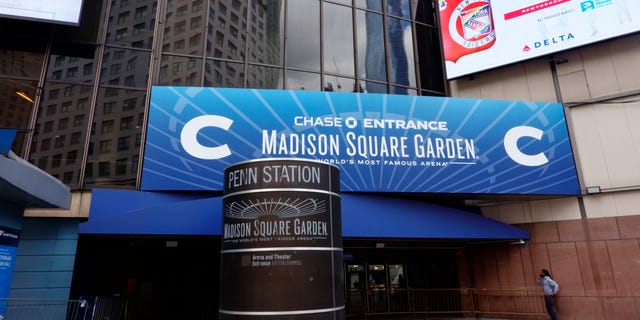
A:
142,87,580,195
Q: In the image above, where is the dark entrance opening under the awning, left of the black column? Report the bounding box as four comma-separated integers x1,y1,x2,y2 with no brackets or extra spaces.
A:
71,235,220,320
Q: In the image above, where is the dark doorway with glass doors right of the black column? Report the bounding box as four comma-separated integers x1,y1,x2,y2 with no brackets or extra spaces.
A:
344,240,461,319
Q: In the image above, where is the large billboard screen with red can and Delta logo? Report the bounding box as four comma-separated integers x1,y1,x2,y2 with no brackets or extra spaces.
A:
439,0,640,79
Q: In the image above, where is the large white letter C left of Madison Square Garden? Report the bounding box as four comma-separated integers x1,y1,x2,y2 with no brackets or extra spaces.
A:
180,115,233,160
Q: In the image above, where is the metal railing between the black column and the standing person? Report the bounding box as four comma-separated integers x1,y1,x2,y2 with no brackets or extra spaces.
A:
346,288,546,319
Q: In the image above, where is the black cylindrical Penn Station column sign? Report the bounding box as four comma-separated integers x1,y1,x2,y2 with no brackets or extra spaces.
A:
220,159,344,320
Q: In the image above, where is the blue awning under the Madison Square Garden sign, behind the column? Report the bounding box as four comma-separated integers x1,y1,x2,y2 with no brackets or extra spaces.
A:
80,189,529,240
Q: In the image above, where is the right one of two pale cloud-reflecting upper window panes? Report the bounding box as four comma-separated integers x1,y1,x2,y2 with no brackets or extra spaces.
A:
323,3,355,76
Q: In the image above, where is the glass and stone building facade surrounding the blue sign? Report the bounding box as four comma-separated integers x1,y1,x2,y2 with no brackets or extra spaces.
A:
0,0,640,319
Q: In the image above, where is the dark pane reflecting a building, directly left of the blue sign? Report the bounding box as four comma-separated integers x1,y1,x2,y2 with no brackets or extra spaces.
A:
84,88,146,188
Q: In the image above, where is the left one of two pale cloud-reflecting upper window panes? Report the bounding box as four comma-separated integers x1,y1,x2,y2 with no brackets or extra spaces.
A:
286,0,320,71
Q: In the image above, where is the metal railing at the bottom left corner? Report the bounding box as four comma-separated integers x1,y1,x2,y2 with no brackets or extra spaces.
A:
0,298,91,320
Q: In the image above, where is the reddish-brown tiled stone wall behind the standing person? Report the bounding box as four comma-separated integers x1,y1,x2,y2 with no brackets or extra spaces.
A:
461,216,640,320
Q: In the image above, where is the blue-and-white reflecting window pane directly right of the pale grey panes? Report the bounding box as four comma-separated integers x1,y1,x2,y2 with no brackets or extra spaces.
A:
356,10,387,82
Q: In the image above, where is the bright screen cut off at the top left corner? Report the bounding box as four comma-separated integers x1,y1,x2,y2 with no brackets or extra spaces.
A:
0,0,82,25
